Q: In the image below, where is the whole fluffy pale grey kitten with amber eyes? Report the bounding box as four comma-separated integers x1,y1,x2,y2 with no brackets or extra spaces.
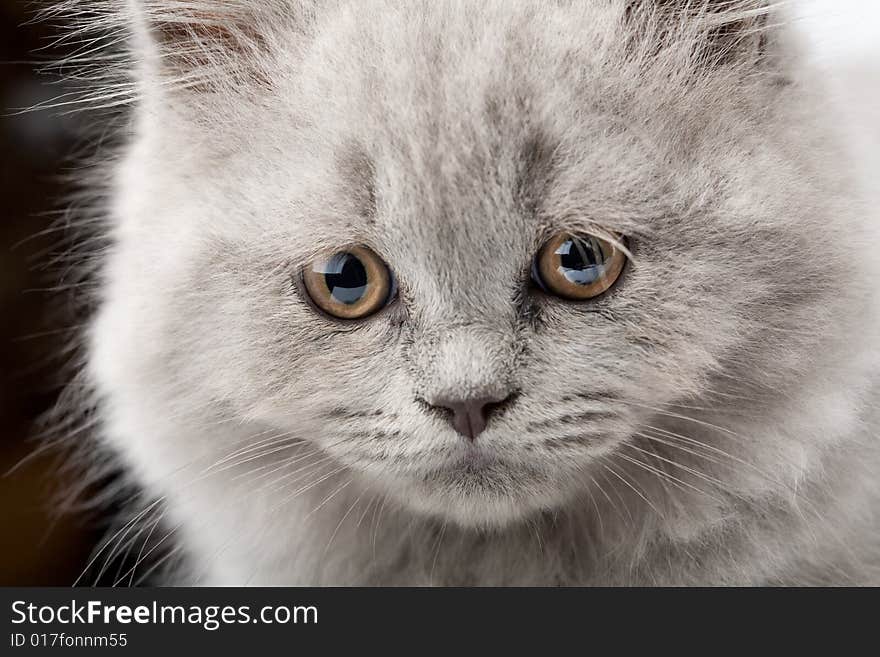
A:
67,0,880,585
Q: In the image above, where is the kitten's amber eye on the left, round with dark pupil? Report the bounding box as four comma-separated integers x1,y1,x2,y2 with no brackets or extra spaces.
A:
302,246,396,319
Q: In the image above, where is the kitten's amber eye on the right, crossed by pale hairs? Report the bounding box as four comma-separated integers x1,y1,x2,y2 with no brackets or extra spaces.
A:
532,233,626,301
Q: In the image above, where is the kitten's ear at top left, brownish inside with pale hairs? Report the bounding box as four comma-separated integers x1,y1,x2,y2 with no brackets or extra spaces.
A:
129,0,296,91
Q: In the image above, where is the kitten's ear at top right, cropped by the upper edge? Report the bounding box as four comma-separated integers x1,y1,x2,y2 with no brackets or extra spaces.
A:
626,0,778,67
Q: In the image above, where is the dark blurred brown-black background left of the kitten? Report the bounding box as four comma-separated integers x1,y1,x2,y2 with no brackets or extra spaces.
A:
0,0,102,585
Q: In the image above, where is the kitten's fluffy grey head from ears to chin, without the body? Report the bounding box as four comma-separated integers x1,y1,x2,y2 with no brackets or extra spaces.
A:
89,0,868,525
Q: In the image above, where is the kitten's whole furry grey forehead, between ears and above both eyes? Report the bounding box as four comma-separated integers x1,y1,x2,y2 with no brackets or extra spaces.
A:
260,2,752,278
